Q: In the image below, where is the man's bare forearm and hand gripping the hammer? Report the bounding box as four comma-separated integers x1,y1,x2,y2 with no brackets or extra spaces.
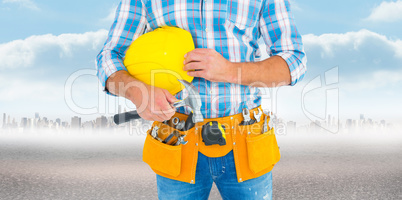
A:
106,70,177,122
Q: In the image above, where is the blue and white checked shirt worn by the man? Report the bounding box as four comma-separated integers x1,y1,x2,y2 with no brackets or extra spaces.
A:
97,0,307,118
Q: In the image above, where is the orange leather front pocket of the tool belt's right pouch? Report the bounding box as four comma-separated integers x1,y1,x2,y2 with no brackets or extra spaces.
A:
246,128,280,173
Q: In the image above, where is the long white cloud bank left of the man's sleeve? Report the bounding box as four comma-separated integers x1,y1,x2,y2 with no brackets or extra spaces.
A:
0,30,107,70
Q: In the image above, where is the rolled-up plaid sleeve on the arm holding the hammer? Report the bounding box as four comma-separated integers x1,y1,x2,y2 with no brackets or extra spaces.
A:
96,0,147,92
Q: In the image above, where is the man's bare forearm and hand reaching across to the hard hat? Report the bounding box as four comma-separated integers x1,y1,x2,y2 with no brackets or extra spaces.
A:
184,49,291,87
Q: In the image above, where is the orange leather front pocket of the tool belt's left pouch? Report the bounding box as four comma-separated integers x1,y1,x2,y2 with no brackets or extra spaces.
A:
142,130,182,177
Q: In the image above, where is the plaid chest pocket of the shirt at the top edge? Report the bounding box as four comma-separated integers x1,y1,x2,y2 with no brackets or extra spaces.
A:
226,0,262,29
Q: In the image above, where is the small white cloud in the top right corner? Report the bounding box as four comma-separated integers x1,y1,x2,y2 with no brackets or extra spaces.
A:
366,0,402,22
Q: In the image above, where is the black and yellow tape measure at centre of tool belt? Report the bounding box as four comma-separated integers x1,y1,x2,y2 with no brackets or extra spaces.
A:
201,121,226,146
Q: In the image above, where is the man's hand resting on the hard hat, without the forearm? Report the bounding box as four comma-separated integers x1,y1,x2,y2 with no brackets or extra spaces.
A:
184,49,236,82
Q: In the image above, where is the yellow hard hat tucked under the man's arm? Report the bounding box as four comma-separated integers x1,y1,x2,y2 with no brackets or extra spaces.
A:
124,26,194,95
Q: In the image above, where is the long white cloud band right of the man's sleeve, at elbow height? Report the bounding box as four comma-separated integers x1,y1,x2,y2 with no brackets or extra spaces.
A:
303,29,402,58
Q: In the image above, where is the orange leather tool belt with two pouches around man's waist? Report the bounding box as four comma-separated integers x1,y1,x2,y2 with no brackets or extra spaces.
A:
143,107,280,184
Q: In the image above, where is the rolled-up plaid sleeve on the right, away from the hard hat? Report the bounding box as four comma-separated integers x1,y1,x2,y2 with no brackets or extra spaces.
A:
259,0,307,85
